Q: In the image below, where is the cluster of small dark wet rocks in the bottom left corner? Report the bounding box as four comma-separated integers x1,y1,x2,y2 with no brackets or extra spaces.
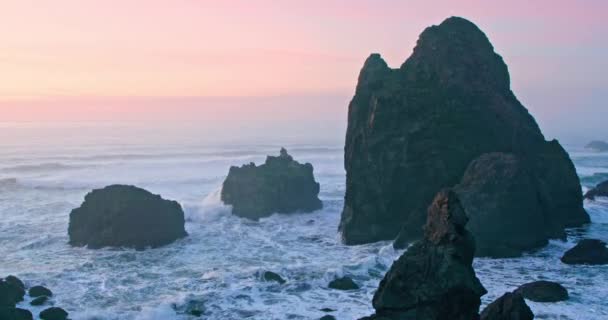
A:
0,276,68,320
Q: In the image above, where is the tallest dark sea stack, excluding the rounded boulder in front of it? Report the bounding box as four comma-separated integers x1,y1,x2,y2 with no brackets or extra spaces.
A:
340,17,588,244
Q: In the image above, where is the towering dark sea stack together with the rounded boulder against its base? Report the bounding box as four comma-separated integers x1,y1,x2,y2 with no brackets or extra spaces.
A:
340,17,589,257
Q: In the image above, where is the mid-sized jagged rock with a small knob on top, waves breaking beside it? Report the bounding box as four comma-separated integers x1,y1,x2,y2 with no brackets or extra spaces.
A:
222,148,323,220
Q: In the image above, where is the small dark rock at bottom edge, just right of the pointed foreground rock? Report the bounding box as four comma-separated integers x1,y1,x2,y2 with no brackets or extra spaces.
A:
480,292,534,320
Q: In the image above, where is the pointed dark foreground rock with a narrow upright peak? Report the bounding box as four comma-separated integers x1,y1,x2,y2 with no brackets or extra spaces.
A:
365,189,486,320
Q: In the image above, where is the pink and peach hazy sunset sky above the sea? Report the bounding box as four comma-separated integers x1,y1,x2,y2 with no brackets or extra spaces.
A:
0,0,608,138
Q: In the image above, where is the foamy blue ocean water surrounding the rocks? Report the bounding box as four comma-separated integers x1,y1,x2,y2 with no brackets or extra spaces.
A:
0,124,608,320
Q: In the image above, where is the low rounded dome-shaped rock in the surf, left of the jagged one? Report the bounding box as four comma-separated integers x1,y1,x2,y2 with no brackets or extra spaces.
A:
68,185,188,249
